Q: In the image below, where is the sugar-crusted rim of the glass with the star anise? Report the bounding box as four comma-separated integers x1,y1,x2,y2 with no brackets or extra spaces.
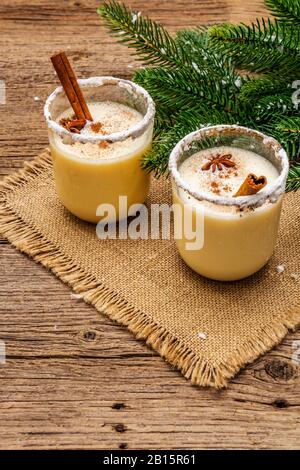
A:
169,124,289,207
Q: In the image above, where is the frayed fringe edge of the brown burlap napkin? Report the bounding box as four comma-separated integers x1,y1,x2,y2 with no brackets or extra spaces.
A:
0,151,300,388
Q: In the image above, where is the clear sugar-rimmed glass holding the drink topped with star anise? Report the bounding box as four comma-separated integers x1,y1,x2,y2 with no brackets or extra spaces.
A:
169,125,289,281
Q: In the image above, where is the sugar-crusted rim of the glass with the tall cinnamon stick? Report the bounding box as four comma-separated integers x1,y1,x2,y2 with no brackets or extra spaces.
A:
44,76,155,143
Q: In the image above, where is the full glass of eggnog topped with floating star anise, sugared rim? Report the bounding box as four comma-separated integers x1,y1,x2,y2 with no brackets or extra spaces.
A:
169,125,289,281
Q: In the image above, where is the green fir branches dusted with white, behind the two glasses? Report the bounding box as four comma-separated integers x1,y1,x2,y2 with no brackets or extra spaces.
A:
98,0,300,190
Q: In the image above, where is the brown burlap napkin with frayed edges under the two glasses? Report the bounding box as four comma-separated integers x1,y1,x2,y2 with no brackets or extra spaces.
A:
0,152,300,387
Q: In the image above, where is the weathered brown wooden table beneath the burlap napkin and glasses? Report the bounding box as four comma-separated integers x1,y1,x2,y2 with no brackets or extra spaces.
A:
0,0,300,449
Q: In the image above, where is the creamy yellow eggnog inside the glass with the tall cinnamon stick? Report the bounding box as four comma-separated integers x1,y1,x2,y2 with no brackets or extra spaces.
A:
50,101,152,222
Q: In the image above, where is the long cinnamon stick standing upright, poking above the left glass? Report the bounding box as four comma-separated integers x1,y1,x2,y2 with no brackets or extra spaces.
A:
51,51,93,121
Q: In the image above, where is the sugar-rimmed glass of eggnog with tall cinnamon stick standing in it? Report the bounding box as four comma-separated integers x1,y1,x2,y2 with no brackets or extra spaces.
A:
44,77,155,223
